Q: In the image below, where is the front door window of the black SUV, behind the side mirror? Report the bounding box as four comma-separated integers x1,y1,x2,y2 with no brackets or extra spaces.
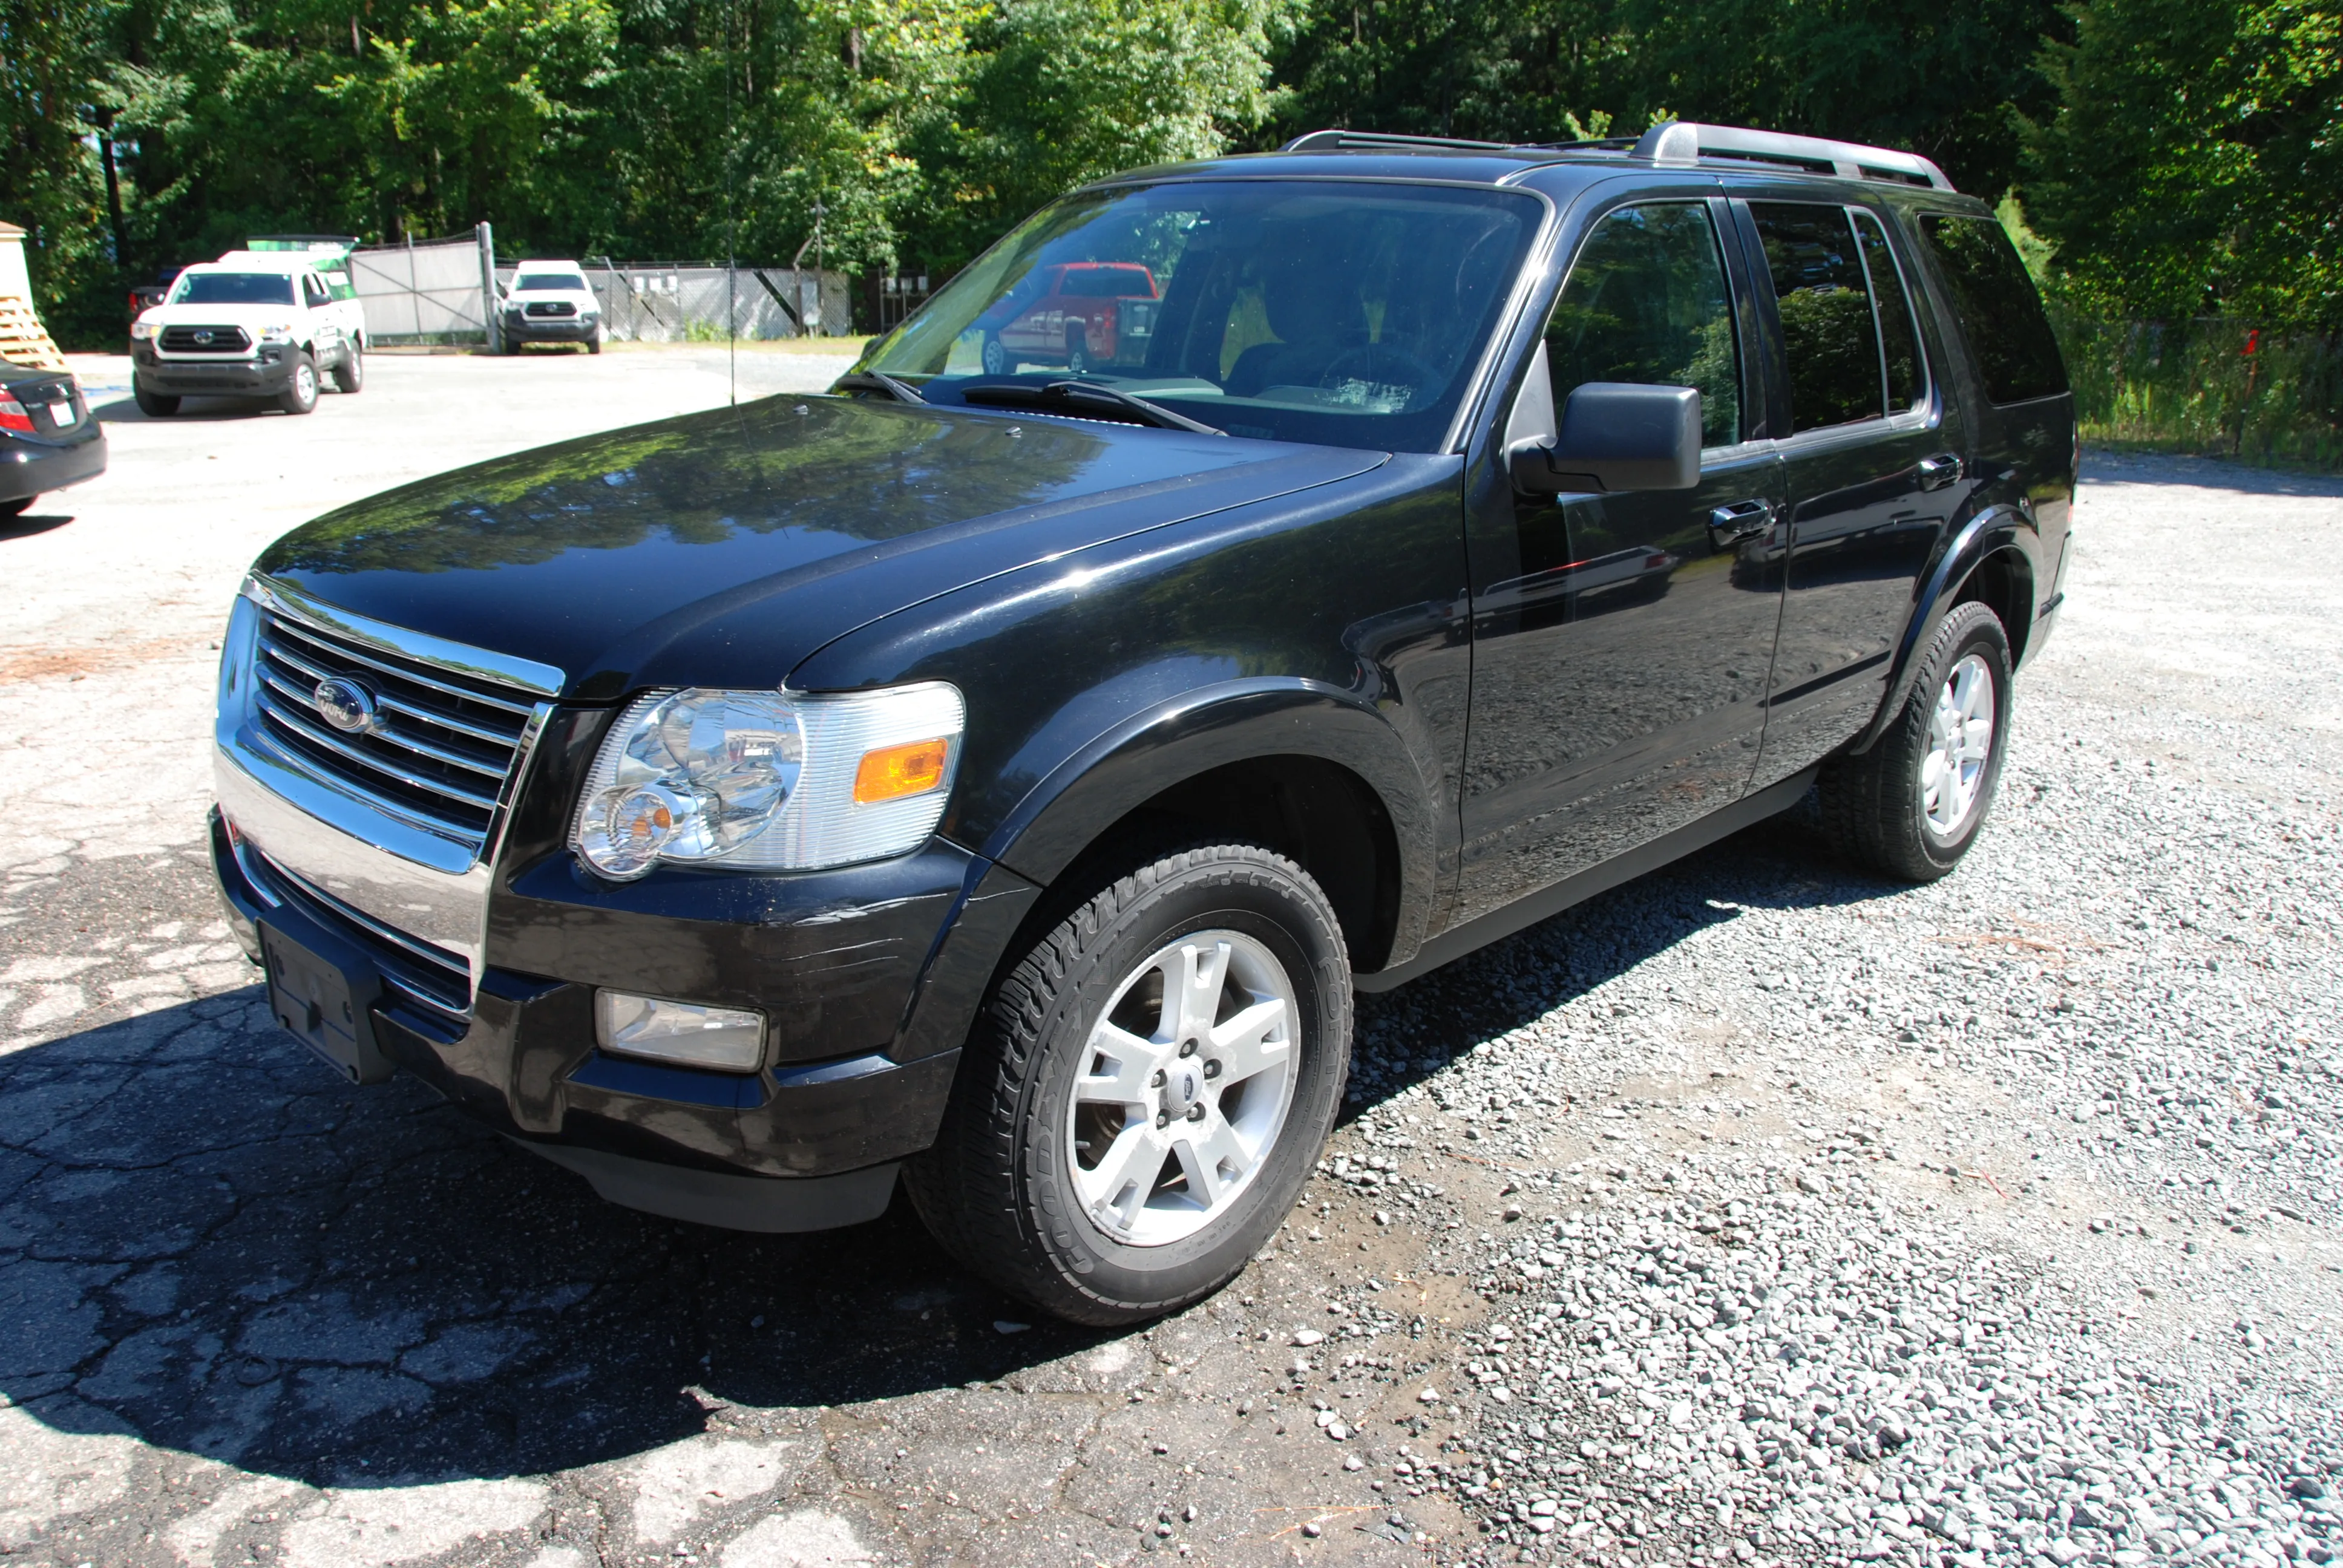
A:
1547,201,1741,448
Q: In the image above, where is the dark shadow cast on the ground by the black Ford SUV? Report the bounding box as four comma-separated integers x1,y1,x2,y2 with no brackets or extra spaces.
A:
0,787,1891,1486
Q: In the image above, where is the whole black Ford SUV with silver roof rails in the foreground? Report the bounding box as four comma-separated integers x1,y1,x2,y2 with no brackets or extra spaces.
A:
213,124,2076,1324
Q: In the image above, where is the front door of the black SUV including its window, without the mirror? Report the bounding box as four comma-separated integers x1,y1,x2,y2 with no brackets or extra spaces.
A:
1455,199,1781,919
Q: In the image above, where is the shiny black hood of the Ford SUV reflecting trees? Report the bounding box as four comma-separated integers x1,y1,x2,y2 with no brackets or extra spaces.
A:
255,394,1384,701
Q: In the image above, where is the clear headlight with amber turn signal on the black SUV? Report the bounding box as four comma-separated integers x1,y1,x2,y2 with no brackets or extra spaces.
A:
569,682,965,881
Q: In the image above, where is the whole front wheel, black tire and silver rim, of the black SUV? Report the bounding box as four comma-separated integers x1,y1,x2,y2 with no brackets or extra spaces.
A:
905,844,1352,1327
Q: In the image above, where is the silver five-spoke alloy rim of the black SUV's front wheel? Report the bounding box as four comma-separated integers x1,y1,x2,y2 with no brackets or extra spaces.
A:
1066,930,1300,1247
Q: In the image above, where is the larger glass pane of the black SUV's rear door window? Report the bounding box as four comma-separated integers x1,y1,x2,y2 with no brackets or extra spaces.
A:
1750,201,1886,434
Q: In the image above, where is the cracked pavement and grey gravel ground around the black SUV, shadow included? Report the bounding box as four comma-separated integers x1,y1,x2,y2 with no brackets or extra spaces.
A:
0,443,2343,1568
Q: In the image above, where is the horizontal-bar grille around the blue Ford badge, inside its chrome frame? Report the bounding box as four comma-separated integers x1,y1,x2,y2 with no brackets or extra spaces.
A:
253,609,537,855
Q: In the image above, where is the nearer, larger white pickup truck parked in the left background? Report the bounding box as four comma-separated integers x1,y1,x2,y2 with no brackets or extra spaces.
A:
131,251,365,417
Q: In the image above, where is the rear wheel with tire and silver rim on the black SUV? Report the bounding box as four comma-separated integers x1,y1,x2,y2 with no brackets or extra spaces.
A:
1818,603,2010,881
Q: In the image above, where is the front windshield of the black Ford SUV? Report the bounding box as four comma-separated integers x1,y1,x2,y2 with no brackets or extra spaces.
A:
860,180,1539,452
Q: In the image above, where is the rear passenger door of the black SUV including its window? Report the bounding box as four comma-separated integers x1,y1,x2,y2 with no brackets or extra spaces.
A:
1734,197,1966,788
